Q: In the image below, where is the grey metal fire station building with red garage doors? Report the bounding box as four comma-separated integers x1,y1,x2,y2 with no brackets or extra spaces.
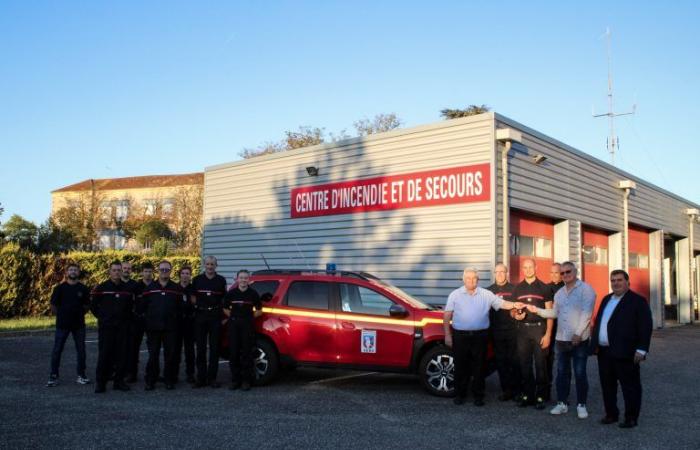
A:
202,113,700,327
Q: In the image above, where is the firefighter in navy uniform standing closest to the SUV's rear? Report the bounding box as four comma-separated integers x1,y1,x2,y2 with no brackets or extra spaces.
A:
224,270,262,391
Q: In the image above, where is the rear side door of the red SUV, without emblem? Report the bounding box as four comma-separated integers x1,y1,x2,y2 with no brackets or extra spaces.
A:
275,280,335,364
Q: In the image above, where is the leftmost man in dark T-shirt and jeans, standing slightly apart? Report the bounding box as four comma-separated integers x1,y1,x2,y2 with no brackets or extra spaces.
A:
46,263,90,387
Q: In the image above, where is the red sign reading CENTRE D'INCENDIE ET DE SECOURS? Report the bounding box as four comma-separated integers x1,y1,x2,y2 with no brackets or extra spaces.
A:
291,164,491,218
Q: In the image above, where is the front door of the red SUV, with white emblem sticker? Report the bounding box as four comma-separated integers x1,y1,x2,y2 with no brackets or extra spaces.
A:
336,282,415,367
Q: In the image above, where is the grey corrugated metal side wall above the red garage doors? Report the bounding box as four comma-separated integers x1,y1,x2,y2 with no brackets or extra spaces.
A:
496,114,700,248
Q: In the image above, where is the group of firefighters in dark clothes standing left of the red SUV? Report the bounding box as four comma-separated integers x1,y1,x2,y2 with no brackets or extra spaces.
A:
47,256,262,393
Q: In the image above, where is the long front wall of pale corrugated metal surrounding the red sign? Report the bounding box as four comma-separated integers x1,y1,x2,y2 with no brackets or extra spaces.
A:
203,114,495,303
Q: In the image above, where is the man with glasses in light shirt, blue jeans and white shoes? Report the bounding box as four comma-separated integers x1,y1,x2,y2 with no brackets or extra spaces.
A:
527,261,596,419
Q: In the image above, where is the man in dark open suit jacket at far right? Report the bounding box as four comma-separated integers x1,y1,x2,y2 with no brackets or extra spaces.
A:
591,270,652,428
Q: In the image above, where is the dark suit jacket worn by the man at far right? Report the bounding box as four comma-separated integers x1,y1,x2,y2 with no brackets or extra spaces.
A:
591,291,653,359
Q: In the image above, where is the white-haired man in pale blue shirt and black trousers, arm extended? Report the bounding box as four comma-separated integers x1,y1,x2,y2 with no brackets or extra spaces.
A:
443,269,524,406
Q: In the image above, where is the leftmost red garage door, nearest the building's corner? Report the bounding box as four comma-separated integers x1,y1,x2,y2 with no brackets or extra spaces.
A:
510,212,554,283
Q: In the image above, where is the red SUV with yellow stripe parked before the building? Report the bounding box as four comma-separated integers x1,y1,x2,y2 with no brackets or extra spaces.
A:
223,270,454,397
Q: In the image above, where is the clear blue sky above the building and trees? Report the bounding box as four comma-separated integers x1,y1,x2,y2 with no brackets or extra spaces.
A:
0,0,700,222
